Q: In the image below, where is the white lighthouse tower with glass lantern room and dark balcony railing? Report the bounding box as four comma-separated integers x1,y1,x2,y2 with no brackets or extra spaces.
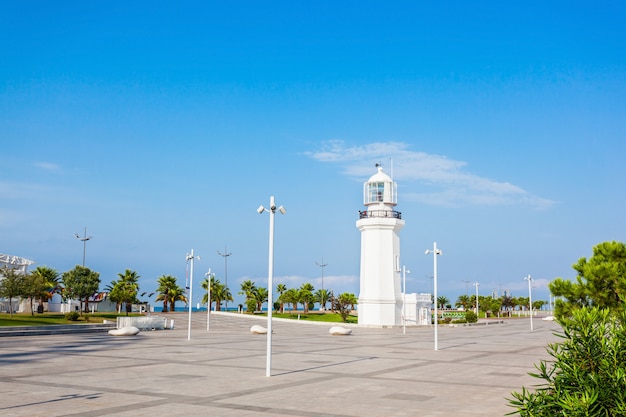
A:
356,165,404,326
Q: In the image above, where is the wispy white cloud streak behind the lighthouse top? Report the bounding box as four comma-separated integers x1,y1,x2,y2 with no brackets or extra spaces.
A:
306,140,554,209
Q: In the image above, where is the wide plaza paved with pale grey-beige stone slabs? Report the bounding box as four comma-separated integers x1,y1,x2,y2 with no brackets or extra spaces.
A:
0,313,560,417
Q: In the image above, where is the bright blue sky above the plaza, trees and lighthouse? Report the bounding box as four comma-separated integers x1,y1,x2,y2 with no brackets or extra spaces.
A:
0,1,626,305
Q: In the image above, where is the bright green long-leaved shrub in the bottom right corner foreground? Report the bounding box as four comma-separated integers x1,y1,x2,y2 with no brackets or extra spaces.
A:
508,307,626,417
